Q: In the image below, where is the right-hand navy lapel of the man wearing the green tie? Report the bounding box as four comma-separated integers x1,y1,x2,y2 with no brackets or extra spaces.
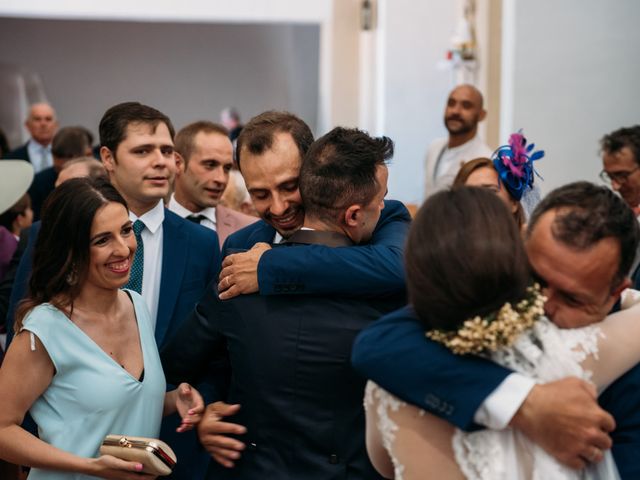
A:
156,209,189,347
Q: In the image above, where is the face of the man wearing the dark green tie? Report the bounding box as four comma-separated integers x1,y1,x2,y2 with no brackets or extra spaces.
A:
100,122,176,216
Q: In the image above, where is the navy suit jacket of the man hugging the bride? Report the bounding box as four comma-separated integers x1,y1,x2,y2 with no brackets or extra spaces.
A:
352,307,640,480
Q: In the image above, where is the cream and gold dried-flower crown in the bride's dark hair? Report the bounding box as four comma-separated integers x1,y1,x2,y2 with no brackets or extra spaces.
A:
426,283,547,355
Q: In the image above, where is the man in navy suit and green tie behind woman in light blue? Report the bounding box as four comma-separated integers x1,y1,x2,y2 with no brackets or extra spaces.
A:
99,102,220,480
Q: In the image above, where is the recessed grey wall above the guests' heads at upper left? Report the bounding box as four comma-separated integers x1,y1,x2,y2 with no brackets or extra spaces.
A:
0,18,320,144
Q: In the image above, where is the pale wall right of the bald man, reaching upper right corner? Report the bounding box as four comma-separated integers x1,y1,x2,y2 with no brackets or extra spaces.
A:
501,0,640,192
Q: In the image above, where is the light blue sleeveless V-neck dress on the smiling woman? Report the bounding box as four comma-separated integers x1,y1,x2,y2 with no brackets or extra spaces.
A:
23,290,166,480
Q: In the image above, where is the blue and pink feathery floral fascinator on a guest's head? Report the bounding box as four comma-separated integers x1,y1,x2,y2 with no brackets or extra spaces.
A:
491,130,544,201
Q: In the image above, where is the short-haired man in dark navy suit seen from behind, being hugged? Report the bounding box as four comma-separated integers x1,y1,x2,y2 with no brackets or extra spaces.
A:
162,127,404,480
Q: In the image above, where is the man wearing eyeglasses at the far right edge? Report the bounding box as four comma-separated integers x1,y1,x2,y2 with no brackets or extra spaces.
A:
600,125,640,290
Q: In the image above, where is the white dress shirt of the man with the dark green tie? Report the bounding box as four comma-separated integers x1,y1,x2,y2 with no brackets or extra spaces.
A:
129,200,164,330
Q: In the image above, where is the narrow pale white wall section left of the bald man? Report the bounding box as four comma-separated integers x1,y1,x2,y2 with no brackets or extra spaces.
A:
376,0,456,204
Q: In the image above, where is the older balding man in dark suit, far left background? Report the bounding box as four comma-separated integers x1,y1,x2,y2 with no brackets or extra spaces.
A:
4,103,58,173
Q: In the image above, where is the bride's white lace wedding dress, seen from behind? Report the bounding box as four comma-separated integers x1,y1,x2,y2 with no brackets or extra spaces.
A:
365,317,620,480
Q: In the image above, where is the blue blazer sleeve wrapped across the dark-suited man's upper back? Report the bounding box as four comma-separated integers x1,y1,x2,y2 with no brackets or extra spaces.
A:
258,200,411,296
